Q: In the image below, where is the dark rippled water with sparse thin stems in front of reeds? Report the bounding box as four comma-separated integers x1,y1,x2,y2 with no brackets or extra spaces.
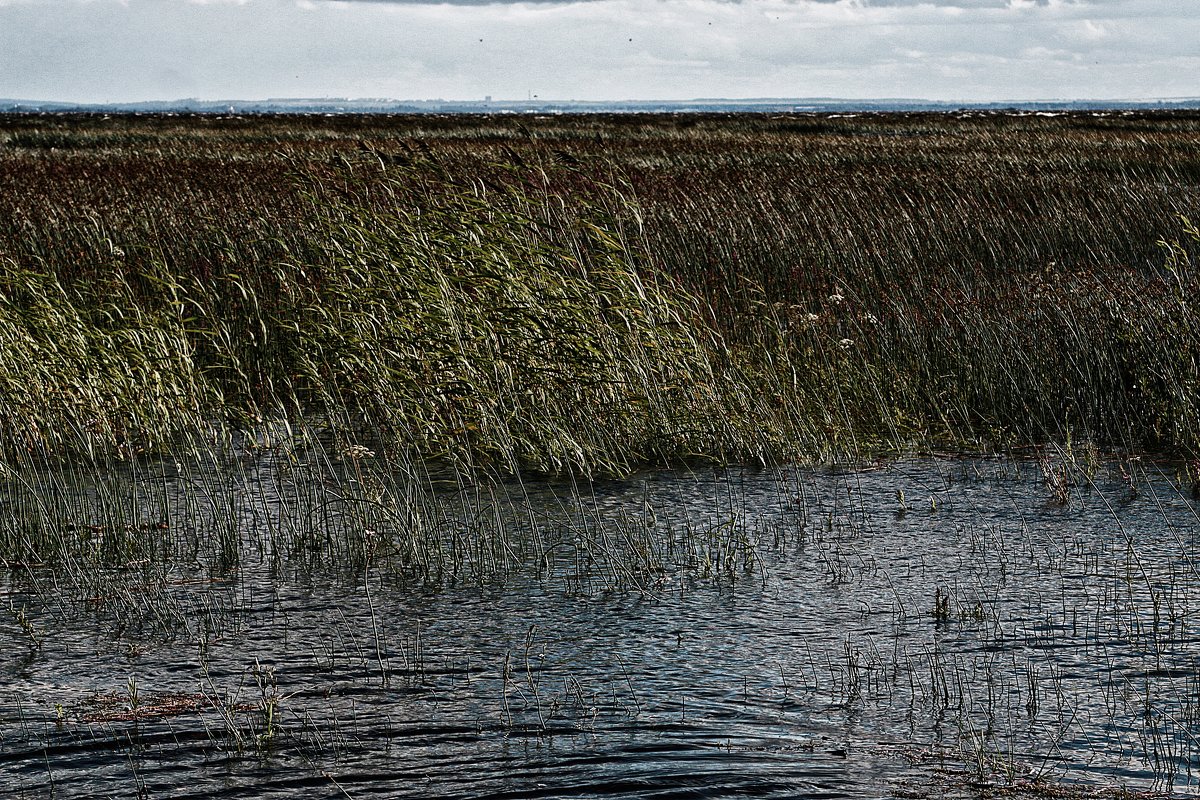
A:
0,458,1200,798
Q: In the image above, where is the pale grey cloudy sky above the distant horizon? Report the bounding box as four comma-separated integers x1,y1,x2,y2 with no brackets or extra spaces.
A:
0,0,1200,102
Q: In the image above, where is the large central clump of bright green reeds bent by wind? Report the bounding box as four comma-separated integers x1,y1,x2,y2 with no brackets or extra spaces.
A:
272,160,796,471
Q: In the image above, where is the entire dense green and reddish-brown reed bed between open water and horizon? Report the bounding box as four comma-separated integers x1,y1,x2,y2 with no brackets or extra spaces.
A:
0,113,1200,475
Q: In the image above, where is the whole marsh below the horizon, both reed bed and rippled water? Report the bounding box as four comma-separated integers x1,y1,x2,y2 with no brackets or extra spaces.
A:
0,112,1200,798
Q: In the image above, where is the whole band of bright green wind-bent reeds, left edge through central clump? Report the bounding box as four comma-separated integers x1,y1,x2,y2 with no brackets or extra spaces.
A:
0,148,816,473
